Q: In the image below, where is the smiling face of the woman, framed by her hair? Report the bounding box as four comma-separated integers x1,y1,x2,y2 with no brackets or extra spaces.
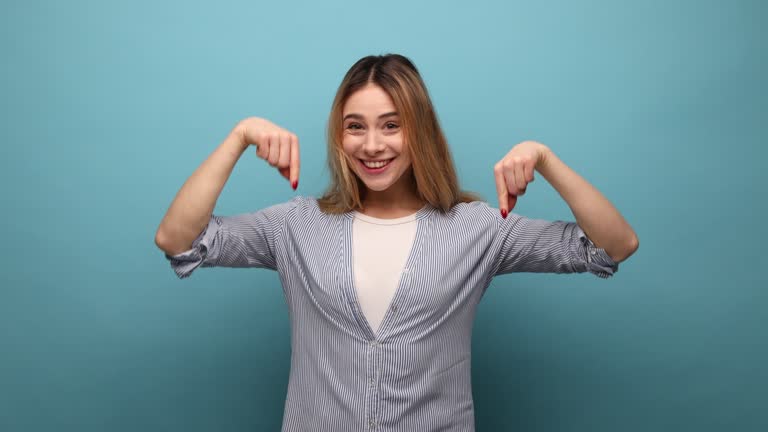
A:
342,84,411,192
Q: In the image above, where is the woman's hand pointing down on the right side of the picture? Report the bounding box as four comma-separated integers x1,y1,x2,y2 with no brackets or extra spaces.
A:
493,141,549,218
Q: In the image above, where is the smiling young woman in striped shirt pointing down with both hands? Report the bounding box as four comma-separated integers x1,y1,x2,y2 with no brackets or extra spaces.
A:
155,55,638,432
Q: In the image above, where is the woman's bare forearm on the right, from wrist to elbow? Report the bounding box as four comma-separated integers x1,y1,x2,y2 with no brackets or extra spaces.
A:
536,148,638,262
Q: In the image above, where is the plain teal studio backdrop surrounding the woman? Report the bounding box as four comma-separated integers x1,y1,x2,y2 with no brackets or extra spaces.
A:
0,0,768,432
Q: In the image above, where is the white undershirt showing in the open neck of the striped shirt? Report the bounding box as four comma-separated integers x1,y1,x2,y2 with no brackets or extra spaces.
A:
352,212,416,333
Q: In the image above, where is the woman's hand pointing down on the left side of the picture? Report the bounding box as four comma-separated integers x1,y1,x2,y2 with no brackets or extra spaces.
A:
235,117,299,190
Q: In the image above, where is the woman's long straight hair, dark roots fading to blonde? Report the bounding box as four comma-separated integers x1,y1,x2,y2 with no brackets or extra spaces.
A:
318,54,480,214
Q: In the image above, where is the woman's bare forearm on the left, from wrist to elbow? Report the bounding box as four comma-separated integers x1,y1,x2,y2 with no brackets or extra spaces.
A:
155,129,248,255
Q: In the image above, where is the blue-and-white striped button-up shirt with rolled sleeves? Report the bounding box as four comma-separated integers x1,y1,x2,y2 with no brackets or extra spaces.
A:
166,197,618,432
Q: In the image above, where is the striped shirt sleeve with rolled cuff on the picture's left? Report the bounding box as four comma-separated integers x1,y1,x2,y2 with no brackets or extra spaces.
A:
165,199,298,278
